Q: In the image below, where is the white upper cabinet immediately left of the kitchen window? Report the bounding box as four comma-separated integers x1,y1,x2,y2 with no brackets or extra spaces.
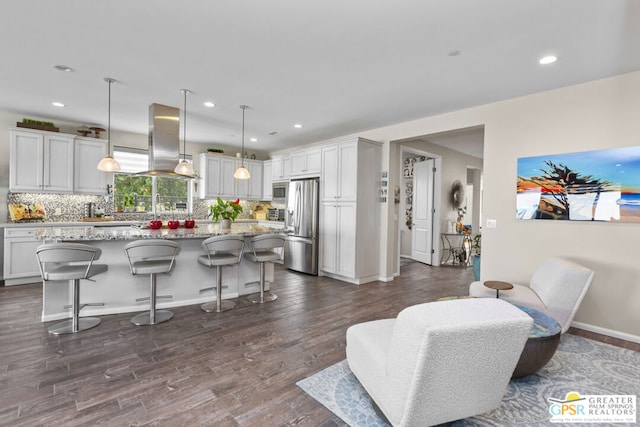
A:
73,137,107,195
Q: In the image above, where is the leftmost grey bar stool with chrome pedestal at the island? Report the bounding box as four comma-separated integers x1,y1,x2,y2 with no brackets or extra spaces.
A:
36,243,108,335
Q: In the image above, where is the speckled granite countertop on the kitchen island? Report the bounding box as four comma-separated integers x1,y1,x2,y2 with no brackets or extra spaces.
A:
36,221,282,241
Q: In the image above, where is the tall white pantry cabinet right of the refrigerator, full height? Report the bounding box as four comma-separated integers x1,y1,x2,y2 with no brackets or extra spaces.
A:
319,138,382,284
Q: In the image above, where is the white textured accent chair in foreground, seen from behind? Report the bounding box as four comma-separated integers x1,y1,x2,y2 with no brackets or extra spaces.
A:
347,298,533,427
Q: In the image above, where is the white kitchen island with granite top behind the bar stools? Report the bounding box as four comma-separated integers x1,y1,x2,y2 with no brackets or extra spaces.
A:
36,223,282,322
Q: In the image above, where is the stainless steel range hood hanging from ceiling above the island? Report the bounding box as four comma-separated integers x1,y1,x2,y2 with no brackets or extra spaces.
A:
136,104,195,179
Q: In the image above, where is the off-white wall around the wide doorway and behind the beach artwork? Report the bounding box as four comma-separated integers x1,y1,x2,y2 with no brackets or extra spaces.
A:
302,72,640,342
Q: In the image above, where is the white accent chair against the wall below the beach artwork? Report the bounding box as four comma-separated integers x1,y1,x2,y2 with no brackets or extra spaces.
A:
469,257,594,334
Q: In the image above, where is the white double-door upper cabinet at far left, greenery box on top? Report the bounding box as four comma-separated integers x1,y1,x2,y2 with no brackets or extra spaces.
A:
9,130,74,193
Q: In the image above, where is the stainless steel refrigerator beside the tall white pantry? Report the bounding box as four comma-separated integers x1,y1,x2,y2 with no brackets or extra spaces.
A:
284,178,320,275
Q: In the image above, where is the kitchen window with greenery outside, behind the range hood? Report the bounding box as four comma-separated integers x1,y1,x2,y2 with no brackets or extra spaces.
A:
113,147,192,214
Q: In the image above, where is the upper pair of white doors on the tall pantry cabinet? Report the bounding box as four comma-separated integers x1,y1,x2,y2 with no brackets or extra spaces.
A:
322,141,358,201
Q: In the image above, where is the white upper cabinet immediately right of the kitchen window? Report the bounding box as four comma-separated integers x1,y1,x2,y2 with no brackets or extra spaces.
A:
198,153,236,199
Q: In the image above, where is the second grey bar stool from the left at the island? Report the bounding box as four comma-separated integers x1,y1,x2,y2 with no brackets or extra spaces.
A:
124,239,180,326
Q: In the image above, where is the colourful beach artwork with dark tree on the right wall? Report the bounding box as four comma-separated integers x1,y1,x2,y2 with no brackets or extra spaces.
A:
516,147,640,222
